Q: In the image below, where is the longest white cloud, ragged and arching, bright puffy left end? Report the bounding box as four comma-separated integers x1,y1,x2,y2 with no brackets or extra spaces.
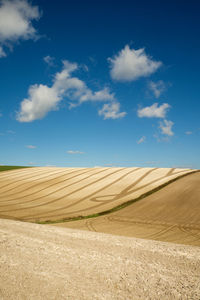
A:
17,60,124,122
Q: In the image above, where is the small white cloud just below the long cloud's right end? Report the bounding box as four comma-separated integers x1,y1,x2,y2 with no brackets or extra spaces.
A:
98,102,126,120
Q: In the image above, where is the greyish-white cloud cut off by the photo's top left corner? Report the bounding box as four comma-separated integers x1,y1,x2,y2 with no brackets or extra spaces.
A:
0,0,41,57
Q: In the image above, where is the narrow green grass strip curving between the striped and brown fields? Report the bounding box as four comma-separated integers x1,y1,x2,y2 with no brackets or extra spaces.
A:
34,170,200,224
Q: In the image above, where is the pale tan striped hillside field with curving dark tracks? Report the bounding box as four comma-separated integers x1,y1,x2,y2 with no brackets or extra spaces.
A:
0,167,192,222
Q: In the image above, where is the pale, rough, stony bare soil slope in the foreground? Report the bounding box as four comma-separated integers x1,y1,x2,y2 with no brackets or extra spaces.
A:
0,219,200,300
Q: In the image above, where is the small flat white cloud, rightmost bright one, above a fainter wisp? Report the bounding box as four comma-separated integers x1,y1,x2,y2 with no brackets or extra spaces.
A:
137,103,170,118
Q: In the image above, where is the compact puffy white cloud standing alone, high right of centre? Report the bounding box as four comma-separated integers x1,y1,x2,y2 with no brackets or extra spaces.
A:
108,45,162,81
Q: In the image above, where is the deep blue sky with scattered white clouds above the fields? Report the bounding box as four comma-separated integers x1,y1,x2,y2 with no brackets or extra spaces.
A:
0,0,200,168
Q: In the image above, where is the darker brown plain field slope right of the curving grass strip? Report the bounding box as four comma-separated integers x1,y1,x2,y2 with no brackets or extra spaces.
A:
55,172,200,246
